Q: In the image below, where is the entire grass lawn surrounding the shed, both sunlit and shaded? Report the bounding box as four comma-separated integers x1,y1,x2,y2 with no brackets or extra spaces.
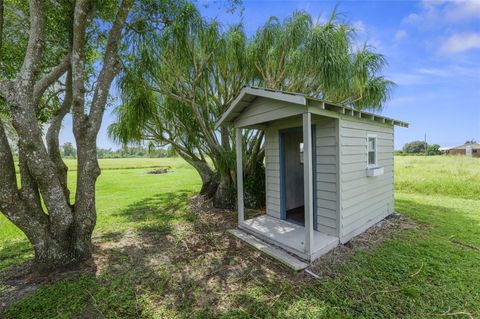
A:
0,157,480,318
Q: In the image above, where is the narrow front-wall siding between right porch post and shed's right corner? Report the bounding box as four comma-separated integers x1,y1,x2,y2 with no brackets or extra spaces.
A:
313,117,338,236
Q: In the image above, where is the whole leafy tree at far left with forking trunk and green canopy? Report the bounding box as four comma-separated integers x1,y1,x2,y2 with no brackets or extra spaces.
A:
0,0,178,270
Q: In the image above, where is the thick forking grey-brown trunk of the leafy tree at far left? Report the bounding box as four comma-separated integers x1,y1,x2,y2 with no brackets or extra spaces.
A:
0,0,133,271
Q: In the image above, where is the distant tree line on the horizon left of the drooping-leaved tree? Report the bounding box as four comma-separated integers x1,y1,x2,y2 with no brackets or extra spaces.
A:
61,142,176,158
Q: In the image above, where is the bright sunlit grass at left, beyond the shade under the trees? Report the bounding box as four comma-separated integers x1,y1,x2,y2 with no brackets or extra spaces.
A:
0,158,200,272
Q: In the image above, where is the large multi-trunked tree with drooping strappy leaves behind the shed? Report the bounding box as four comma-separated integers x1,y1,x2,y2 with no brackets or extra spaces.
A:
109,6,393,207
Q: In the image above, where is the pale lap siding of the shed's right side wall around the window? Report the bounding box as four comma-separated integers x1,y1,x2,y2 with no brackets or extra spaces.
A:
340,119,393,242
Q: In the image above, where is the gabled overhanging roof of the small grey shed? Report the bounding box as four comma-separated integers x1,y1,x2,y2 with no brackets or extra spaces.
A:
215,86,408,128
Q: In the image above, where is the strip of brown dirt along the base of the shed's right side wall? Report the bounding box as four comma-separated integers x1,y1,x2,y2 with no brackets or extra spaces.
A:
308,213,417,277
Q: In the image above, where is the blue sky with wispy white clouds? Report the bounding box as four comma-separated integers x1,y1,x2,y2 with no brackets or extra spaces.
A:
60,0,480,149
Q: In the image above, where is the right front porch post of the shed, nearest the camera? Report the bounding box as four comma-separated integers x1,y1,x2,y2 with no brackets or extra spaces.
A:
303,112,314,255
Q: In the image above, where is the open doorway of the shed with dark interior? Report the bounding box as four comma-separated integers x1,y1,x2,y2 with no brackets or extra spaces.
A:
280,127,316,229
